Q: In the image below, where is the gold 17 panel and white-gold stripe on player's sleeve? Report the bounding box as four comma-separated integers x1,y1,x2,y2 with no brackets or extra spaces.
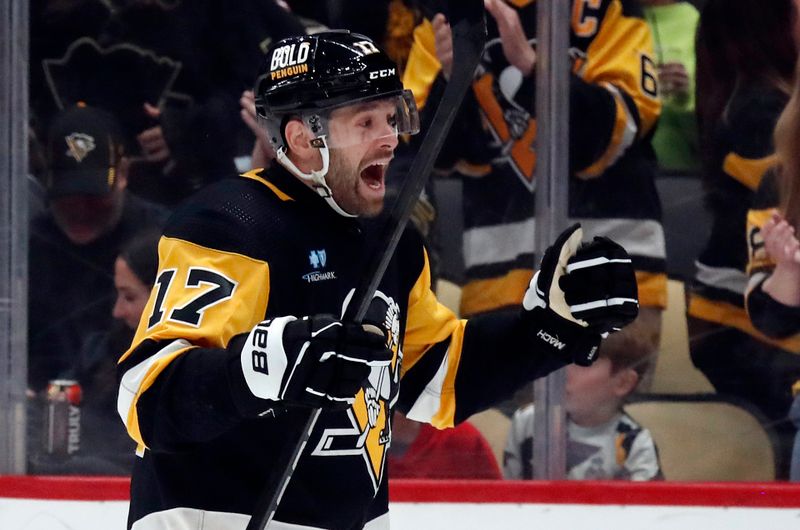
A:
118,233,270,445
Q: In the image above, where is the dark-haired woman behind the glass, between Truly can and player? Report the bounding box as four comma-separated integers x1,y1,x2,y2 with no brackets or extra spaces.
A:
29,231,161,475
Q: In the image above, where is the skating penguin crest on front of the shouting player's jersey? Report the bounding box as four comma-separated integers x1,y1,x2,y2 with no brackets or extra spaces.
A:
311,291,403,491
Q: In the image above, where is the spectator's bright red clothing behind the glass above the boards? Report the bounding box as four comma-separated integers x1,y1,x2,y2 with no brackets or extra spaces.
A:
389,412,502,480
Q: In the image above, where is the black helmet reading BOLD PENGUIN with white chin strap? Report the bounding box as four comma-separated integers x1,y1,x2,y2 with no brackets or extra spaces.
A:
254,30,419,215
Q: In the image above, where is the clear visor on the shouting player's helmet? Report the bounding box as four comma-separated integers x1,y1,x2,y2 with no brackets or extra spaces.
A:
305,90,419,149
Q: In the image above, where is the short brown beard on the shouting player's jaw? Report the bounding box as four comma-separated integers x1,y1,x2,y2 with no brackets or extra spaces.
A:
325,148,383,217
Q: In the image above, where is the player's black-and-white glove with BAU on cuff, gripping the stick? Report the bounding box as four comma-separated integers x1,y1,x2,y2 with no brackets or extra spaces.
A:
241,315,393,409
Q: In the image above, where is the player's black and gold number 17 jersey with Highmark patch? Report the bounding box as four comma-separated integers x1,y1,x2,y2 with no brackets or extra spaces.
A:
118,166,566,530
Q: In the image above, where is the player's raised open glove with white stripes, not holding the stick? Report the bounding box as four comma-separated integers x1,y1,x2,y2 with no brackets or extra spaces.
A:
522,224,639,366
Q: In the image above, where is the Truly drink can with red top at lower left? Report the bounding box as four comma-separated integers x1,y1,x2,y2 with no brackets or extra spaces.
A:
44,379,83,457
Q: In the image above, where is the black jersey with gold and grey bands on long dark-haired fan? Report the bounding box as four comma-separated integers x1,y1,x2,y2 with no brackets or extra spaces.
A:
688,83,796,349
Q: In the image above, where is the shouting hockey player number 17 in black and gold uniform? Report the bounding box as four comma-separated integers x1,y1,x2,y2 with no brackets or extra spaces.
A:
118,31,637,530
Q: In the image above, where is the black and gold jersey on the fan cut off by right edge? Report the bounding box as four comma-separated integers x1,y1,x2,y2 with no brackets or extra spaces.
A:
745,168,800,353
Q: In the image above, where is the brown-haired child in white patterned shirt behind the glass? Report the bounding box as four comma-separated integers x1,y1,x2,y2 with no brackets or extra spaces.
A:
503,323,663,480
